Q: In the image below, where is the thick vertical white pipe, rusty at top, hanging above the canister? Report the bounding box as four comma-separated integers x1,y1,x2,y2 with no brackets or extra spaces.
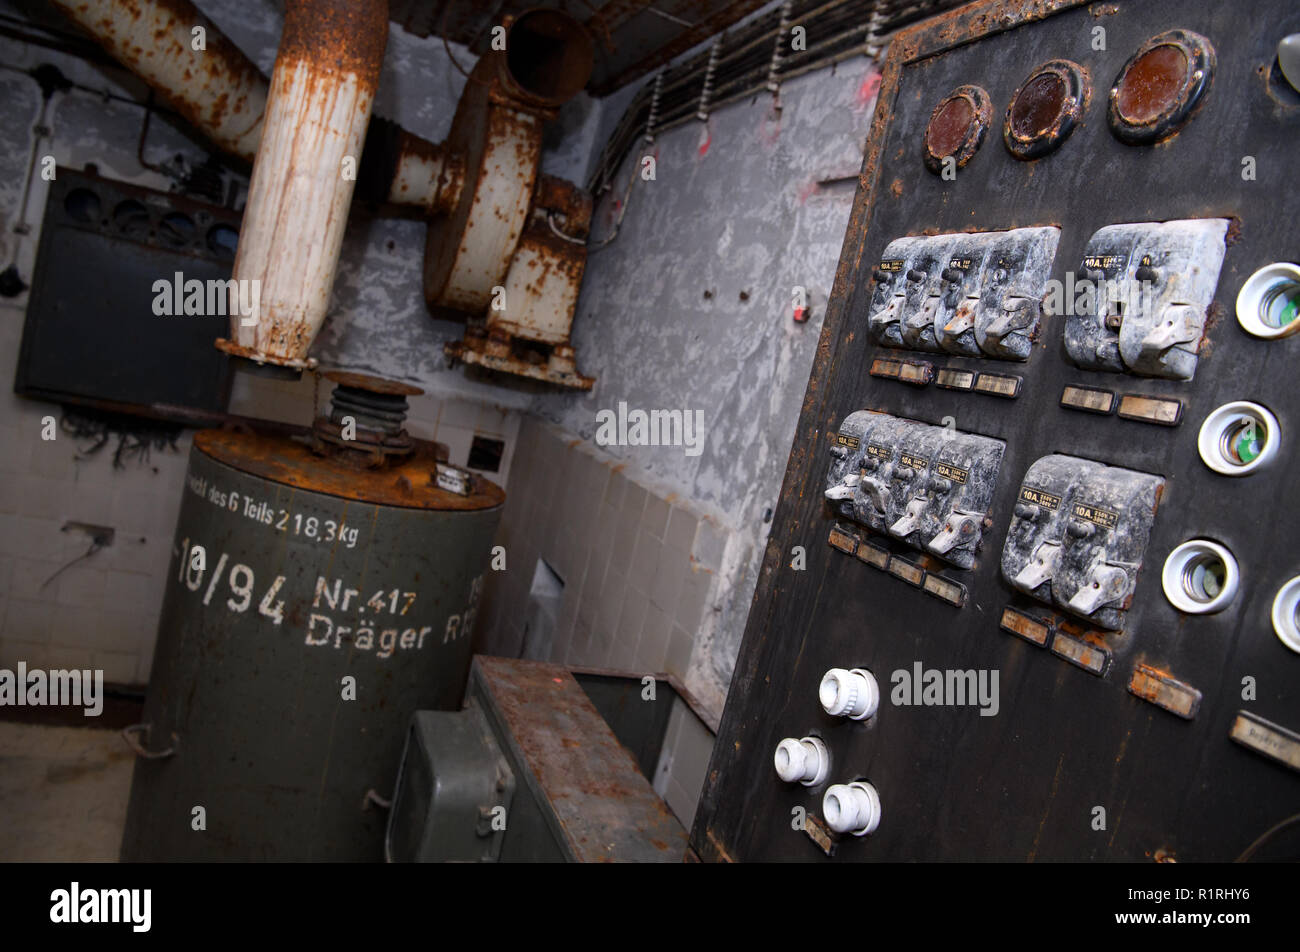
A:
218,0,389,368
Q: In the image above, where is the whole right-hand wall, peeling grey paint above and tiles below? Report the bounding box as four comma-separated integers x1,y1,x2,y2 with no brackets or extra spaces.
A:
480,53,878,826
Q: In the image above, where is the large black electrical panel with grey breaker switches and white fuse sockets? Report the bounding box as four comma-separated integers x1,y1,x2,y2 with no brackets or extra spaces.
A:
692,0,1300,862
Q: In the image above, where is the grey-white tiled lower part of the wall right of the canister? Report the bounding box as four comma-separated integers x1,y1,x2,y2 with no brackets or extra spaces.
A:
476,417,727,826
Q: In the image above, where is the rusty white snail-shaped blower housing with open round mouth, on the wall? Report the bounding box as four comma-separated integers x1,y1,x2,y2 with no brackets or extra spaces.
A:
424,10,595,390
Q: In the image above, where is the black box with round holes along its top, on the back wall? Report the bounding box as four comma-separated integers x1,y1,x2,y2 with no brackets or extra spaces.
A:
14,169,239,423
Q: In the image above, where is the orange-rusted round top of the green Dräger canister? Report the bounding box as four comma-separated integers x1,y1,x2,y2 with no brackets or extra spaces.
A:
194,429,506,511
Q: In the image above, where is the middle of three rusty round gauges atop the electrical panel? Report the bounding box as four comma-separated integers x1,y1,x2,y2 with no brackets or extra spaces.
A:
1002,60,1092,160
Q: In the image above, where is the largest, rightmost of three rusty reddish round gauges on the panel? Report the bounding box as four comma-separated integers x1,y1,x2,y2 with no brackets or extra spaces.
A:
1108,30,1214,146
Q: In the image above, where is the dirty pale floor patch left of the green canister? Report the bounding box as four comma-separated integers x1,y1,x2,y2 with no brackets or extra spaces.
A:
0,721,135,862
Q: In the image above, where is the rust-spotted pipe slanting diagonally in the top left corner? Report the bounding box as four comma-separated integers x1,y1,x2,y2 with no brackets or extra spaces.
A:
51,0,267,160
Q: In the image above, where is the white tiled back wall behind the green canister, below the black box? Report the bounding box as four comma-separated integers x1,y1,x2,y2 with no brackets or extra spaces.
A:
0,306,519,684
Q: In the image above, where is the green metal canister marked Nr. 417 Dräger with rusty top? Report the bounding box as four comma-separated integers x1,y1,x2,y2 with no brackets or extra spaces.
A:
122,430,504,861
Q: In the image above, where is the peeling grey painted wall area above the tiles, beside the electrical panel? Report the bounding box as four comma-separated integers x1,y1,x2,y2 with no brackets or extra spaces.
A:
530,59,879,709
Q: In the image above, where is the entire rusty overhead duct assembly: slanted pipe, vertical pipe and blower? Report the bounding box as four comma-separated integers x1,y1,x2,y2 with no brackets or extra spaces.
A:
55,0,594,389
